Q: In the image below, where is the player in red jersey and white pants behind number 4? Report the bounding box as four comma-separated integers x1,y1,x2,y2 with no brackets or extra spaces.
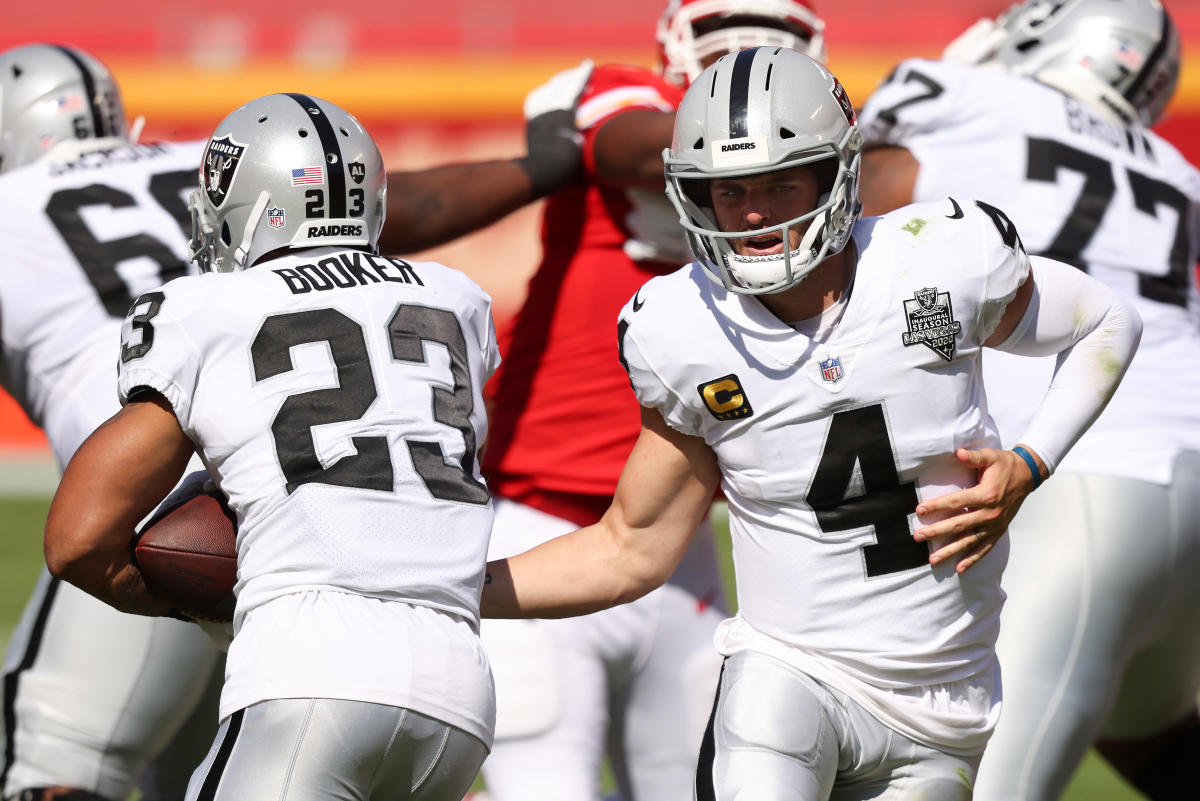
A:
388,0,824,801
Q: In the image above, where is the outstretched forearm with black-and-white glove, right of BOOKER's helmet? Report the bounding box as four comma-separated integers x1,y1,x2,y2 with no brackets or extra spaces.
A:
379,61,593,253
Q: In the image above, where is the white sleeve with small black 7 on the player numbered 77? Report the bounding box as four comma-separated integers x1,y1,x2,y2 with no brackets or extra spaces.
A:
858,59,964,149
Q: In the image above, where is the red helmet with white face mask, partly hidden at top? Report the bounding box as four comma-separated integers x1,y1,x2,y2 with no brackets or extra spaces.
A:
658,0,826,86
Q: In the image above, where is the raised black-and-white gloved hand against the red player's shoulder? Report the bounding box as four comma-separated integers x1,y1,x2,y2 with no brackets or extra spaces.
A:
517,60,594,198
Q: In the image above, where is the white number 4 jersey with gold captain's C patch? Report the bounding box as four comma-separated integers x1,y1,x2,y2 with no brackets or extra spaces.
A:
619,200,1030,751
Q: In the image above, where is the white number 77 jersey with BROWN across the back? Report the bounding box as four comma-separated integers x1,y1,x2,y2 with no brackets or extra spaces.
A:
860,59,1200,483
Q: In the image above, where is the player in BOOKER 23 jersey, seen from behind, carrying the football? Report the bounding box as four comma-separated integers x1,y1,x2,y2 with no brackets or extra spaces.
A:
46,94,498,801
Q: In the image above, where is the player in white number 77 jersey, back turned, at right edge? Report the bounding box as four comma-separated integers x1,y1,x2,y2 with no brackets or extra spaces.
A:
863,0,1200,801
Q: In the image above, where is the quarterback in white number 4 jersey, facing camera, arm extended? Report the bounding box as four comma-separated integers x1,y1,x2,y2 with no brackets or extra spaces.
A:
484,47,1141,801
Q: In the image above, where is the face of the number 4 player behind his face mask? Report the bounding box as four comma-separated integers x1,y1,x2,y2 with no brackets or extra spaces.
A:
708,165,820,257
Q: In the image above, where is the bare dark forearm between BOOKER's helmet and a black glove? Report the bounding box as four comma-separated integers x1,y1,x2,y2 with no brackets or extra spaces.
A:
379,159,534,253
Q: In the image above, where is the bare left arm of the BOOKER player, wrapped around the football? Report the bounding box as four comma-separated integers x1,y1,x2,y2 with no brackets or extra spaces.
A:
44,393,194,615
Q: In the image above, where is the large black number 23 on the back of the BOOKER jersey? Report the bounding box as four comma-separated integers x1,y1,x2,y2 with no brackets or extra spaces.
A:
250,305,490,506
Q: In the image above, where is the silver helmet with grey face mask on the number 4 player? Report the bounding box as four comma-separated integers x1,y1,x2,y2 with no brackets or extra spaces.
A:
662,47,863,295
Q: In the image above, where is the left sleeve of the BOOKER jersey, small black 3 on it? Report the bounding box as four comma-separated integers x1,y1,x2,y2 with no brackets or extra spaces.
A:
116,278,202,432
